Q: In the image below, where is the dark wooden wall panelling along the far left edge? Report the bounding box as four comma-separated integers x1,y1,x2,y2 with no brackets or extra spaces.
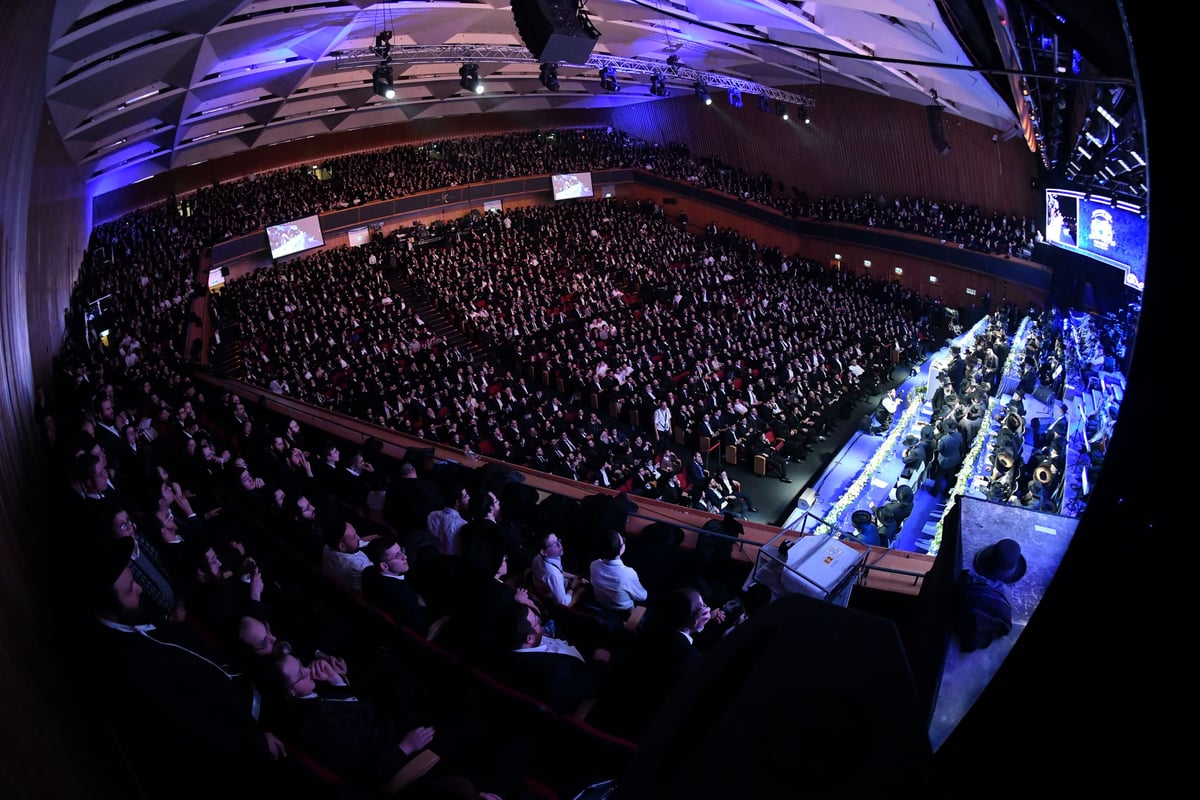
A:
0,2,118,799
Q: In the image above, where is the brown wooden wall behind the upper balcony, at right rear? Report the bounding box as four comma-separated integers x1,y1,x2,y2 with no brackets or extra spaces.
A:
612,86,1043,219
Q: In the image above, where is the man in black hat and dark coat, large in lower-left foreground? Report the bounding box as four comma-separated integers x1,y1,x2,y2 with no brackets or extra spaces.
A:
84,539,284,798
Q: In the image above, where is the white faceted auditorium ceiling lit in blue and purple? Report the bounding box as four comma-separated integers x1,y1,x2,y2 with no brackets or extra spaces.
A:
46,0,1144,200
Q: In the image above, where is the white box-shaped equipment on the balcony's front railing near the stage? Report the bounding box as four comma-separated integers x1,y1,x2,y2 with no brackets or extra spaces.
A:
743,534,870,606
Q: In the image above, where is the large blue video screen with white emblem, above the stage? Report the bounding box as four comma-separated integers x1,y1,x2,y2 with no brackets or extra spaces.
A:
1045,190,1150,291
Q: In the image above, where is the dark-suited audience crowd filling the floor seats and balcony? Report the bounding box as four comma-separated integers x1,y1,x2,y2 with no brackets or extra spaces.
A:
42,123,1046,798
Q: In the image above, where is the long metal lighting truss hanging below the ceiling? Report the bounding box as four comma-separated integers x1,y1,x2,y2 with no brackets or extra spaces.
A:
331,44,817,108
